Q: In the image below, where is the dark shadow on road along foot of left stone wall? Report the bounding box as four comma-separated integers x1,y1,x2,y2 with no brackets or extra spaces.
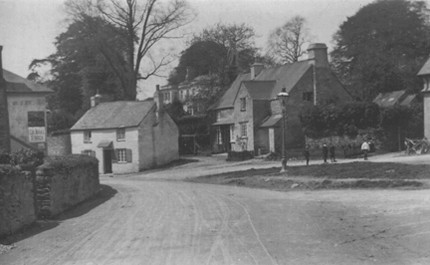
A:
0,184,117,245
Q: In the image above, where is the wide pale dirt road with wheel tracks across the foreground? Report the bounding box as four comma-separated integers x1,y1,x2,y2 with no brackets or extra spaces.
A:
0,154,430,265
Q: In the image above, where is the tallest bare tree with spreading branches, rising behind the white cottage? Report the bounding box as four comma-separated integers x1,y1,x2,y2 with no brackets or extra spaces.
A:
67,0,193,100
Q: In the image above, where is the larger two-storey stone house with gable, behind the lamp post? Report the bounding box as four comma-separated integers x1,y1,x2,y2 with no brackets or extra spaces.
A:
211,43,352,154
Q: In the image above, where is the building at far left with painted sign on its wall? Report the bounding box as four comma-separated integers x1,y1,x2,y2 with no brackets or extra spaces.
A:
0,45,53,152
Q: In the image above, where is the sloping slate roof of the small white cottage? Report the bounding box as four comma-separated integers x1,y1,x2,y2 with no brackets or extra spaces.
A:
71,99,155,131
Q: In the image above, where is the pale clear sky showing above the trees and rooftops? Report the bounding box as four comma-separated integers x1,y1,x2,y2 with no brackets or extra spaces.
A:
0,0,380,99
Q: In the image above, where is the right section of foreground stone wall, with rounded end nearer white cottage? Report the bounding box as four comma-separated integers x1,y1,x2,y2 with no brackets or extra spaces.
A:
35,155,100,218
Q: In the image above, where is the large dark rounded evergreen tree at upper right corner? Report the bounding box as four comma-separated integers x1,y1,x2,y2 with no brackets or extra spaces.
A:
331,0,430,101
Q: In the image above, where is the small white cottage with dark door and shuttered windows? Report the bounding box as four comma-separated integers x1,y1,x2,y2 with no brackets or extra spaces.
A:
71,98,179,173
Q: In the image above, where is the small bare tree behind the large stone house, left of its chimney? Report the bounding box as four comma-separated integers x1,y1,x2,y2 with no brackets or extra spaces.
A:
268,16,310,63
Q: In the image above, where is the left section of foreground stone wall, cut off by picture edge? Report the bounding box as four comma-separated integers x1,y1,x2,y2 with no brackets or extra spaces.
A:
0,166,36,237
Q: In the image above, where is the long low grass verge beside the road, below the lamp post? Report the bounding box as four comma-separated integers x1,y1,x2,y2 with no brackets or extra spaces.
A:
188,162,430,191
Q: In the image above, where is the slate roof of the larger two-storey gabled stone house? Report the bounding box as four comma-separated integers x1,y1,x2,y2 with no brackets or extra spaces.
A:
211,60,312,110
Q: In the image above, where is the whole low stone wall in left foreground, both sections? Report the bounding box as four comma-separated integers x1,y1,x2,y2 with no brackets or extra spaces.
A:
0,155,100,237
